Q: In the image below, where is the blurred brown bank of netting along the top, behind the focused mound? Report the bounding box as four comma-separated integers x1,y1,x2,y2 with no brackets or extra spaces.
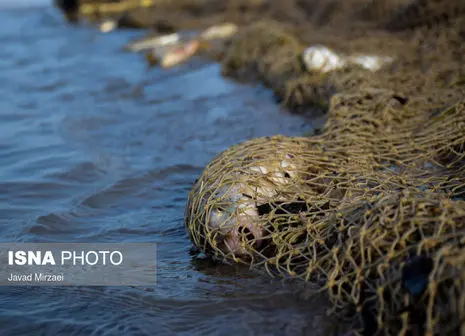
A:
55,0,465,117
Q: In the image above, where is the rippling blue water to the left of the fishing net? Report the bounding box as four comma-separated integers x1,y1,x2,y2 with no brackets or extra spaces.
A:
0,6,334,335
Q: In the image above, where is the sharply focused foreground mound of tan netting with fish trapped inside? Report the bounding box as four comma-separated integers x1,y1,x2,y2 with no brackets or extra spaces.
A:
186,94,465,334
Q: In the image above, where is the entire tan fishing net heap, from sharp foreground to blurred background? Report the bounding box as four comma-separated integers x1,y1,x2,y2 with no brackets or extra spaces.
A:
186,0,465,335
